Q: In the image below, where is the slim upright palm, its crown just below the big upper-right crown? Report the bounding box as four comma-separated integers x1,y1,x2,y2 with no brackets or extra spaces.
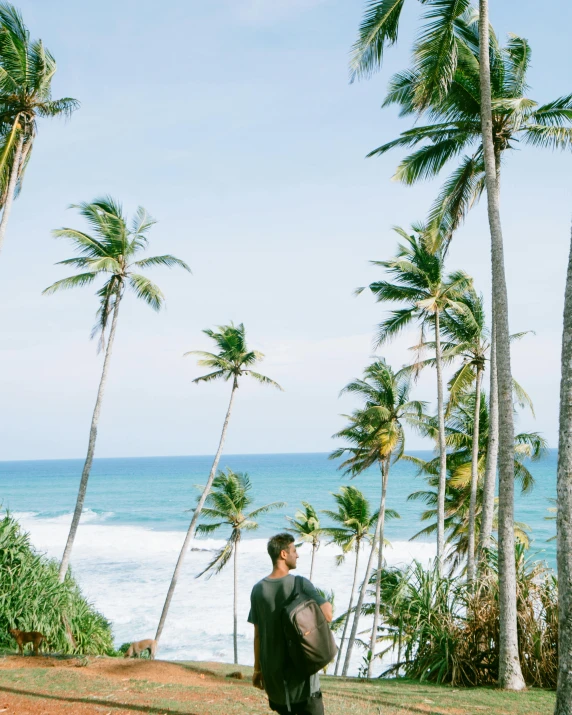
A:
360,226,472,562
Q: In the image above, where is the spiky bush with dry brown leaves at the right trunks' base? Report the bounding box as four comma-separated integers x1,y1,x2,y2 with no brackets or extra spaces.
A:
366,545,558,687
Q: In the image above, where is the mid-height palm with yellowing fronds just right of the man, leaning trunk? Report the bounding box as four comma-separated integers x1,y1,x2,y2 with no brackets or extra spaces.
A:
330,359,424,677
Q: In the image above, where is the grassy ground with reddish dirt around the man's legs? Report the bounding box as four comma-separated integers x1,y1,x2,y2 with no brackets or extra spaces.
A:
0,657,554,715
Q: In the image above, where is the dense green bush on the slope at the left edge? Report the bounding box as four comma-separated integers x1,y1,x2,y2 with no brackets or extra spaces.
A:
0,514,114,655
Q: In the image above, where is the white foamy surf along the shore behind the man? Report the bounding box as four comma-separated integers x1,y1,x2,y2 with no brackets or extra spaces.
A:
19,512,435,673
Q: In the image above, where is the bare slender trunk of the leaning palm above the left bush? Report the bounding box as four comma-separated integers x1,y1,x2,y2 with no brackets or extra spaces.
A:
58,296,121,583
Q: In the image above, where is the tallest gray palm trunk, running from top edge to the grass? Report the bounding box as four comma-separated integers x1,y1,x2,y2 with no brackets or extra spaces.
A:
479,0,525,690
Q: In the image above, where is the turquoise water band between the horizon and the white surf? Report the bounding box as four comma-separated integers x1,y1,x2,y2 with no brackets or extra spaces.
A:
0,450,556,566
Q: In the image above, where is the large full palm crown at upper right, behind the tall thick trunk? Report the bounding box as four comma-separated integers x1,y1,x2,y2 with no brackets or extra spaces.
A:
368,30,572,242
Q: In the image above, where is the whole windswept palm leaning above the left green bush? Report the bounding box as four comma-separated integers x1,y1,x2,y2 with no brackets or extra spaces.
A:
43,196,190,581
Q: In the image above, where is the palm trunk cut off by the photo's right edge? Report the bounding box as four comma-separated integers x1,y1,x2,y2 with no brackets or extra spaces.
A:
554,225,572,715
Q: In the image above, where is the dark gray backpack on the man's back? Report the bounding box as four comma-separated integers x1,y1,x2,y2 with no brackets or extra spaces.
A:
282,576,338,678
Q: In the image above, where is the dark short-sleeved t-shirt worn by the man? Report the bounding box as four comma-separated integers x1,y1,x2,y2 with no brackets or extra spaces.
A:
248,574,326,705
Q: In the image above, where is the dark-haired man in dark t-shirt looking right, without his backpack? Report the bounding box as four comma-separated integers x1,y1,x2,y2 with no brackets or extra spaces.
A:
248,534,332,715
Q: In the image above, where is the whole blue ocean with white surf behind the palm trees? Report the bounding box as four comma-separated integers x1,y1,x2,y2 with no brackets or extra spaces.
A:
0,450,557,673
